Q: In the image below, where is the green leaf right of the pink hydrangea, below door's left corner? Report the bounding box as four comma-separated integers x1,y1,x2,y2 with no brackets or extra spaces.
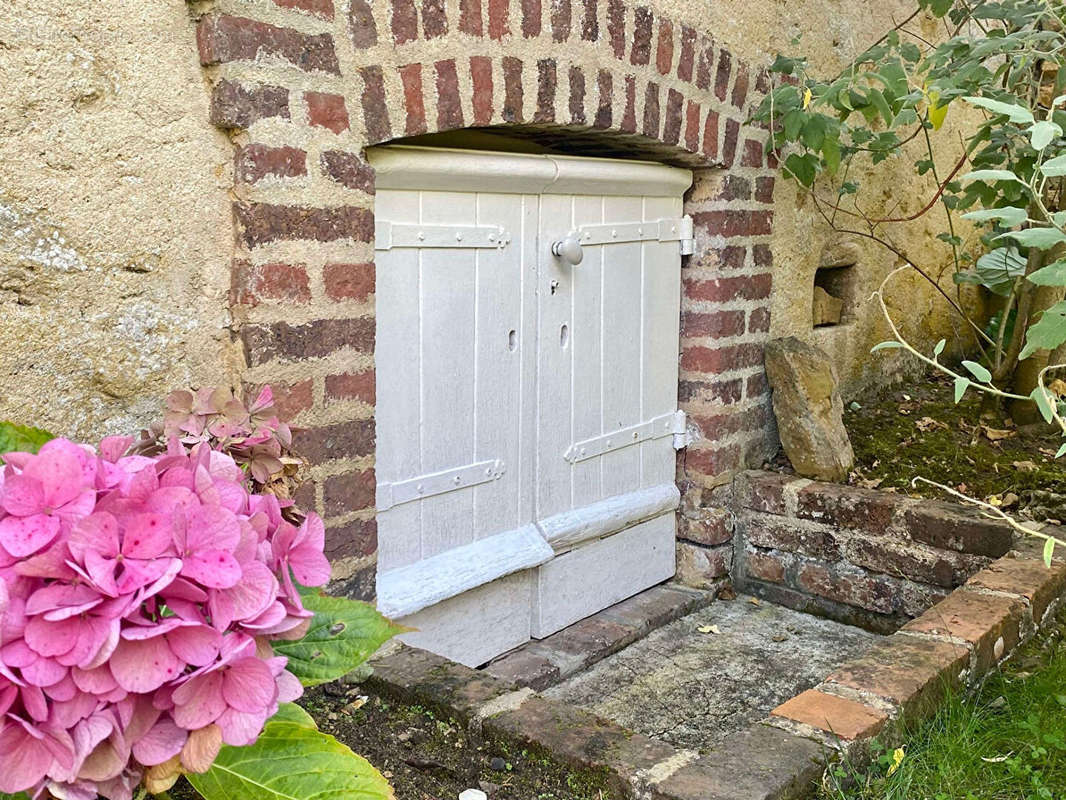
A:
272,593,407,686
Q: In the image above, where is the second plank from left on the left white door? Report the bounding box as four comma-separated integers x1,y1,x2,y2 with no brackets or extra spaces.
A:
420,192,478,558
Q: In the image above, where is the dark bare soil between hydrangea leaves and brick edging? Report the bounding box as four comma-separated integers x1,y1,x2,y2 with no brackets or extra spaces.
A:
171,683,612,800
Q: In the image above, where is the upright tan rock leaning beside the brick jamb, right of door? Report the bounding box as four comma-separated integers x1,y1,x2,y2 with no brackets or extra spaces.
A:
766,336,855,481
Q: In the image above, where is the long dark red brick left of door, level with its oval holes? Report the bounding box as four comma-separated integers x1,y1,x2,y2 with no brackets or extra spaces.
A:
241,317,374,367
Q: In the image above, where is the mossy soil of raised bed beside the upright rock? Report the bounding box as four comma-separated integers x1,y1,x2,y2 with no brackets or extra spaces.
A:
844,374,1066,522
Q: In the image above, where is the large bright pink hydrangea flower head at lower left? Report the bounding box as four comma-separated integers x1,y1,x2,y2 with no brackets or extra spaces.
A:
0,433,329,800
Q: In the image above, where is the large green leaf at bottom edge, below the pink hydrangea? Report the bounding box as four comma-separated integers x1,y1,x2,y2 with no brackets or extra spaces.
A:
187,722,394,800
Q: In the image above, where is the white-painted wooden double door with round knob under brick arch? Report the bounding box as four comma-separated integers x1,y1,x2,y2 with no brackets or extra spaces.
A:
371,146,691,666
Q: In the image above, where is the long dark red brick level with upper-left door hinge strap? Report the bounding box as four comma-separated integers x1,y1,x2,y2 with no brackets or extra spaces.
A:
236,203,374,247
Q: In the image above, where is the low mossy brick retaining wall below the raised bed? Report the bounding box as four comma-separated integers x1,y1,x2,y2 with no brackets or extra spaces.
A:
723,471,1013,631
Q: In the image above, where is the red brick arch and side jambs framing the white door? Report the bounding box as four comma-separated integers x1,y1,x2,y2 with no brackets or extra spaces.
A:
189,0,776,596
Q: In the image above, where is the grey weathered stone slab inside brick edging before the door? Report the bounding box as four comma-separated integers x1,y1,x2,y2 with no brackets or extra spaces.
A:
544,595,883,752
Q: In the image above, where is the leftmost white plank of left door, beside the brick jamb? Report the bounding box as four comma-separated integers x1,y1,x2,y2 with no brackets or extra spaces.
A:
374,190,422,572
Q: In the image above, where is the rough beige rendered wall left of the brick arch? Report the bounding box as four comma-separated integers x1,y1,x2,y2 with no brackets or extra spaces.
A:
0,0,239,439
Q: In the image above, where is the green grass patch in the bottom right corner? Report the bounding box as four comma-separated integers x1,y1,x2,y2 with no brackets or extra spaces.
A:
820,614,1066,800
